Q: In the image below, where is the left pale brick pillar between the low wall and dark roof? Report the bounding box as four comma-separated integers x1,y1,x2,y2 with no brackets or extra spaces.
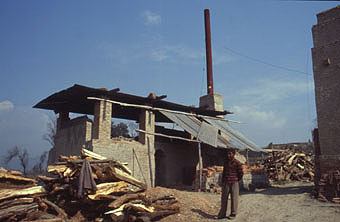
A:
93,100,112,140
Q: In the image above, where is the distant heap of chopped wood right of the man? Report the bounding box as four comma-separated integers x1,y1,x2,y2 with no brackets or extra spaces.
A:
264,149,314,181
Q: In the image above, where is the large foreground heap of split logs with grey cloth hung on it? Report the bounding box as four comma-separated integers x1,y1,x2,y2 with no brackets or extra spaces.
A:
0,150,179,222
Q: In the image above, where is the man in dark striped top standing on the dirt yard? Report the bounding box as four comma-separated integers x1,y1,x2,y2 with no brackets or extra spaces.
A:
218,149,243,219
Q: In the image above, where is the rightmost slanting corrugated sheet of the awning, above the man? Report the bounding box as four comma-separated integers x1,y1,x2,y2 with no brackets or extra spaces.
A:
203,118,267,152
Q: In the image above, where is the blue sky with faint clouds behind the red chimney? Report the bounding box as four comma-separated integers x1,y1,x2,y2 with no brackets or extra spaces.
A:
0,0,338,160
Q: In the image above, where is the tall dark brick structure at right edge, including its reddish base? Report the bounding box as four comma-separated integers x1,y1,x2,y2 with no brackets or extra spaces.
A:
312,6,340,201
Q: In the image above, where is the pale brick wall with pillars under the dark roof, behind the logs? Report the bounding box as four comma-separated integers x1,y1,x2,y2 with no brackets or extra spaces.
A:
48,100,155,187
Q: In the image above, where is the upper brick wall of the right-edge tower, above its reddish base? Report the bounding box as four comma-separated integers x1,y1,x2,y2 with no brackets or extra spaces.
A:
312,4,340,161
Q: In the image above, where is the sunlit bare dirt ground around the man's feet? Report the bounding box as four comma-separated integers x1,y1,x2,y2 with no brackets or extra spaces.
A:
160,182,340,222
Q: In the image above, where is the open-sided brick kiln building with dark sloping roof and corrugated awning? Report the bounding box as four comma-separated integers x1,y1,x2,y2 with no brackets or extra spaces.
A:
34,85,261,189
